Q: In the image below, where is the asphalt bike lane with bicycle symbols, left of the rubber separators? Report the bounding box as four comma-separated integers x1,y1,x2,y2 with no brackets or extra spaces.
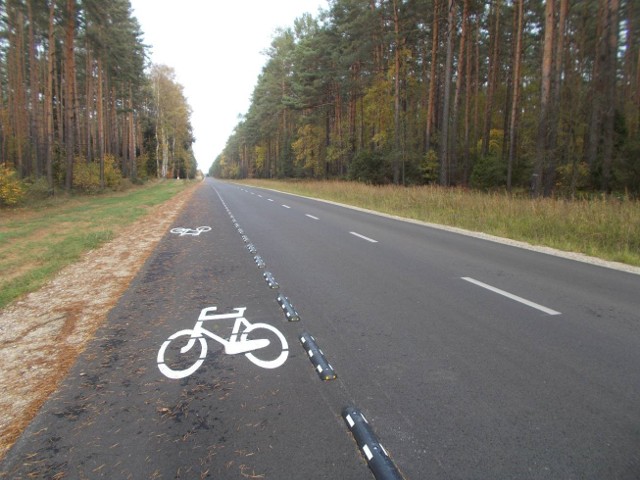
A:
0,182,371,479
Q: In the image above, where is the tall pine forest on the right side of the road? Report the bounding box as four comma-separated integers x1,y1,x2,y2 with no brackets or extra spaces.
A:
210,0,640,197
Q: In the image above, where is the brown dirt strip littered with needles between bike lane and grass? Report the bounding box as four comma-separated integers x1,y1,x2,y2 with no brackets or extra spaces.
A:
0,182,197,460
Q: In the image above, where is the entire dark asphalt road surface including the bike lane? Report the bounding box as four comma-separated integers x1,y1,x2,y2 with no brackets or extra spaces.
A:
0,179,640,479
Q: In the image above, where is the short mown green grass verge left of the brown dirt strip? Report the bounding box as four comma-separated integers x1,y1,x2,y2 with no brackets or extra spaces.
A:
0,181,192,308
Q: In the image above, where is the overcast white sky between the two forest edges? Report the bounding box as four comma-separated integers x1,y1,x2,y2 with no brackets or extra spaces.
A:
131,0,328,173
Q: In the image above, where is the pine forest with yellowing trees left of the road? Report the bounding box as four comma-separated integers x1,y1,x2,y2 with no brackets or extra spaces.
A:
0,0,197,204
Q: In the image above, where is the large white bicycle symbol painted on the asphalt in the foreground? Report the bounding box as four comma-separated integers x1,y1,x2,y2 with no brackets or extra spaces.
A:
158,307,289,379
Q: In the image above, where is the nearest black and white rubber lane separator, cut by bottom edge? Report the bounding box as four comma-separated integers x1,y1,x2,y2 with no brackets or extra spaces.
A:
342,407,404,480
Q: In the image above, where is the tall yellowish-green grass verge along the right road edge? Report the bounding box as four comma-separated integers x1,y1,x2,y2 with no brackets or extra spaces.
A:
236,180,640,266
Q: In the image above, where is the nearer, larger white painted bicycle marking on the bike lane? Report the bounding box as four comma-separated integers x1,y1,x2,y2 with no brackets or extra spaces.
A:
158,307,289,379
